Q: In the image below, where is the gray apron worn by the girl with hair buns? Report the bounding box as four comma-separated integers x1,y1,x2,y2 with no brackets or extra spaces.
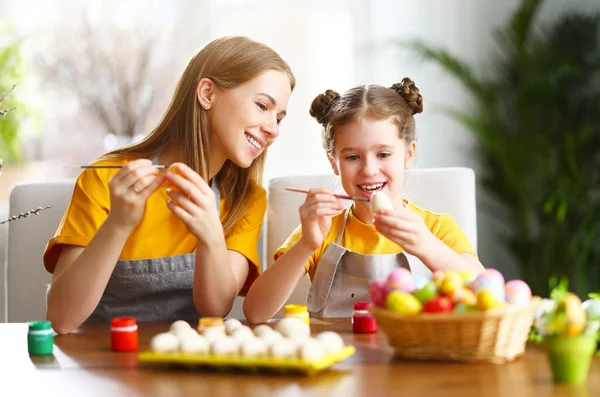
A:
307,207,410,318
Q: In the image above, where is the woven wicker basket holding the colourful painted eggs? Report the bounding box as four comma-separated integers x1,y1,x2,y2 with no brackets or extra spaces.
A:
371,297,540,364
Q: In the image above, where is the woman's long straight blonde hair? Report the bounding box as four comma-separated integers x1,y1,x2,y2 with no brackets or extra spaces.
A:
103,37,296,236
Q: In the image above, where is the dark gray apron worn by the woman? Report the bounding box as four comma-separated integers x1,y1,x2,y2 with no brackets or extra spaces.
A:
88,178,221,322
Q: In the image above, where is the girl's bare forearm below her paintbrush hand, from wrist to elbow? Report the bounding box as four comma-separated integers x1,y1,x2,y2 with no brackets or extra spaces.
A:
244,237,315,324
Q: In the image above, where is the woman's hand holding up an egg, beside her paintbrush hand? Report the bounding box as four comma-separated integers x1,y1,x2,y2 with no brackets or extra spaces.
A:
165,163,223,245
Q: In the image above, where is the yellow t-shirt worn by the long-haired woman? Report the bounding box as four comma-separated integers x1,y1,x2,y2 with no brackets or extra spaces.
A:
44,160,267,294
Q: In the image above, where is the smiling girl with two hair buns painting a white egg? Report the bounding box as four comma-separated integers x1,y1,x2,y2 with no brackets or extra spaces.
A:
244,78,483,323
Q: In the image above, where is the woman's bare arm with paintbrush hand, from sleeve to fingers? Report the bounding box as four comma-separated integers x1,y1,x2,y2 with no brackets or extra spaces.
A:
46,160,163,334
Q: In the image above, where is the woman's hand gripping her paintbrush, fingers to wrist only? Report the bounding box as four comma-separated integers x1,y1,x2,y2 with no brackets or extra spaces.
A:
107,159,164,229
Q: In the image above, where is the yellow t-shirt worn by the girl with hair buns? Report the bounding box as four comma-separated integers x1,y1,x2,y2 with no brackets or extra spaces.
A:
274,200,476,281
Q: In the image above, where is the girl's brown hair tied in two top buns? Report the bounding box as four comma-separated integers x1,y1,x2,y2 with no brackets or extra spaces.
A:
310,77,423,157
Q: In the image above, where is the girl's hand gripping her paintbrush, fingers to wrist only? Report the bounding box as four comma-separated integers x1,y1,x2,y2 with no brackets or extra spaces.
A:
299,189,344,250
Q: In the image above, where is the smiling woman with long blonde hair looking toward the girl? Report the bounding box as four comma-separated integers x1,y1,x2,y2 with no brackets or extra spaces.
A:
44,37,295,333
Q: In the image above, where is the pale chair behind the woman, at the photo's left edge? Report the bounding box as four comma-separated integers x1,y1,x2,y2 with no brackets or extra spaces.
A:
0,179,246,322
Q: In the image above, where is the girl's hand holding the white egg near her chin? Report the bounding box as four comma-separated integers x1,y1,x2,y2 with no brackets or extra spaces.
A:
373,208,437,258
